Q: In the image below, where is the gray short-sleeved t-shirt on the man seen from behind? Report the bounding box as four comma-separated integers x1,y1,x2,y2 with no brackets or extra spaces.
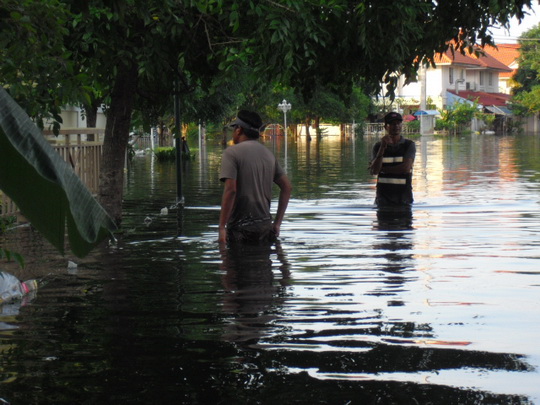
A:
219,140,285,224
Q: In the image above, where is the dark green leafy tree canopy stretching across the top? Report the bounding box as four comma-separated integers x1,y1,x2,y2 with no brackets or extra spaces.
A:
0,0,530,120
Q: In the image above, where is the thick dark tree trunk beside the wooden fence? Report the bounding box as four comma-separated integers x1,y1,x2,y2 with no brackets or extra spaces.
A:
99,64,137,225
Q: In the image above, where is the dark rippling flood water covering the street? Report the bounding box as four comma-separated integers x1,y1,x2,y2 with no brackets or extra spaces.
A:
0,135,540,404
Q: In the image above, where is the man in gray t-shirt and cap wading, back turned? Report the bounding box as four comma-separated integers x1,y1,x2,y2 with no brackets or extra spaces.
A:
218,110,292,243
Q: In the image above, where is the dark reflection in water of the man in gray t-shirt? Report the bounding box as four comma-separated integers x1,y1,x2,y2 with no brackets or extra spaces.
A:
222,241,289,344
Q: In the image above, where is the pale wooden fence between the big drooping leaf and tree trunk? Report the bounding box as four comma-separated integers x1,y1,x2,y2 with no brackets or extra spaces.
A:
0,128,104,217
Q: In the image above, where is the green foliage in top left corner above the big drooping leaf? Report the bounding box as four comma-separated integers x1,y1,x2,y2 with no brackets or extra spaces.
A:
0,0,84,129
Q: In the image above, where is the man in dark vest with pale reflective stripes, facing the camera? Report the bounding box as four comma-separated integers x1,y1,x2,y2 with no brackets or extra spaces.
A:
369,112,416,207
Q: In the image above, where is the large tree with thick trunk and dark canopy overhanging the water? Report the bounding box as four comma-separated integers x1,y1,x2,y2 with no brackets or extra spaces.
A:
0,0,530,222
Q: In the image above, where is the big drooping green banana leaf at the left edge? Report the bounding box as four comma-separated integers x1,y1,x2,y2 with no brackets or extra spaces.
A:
0,88,116,257
